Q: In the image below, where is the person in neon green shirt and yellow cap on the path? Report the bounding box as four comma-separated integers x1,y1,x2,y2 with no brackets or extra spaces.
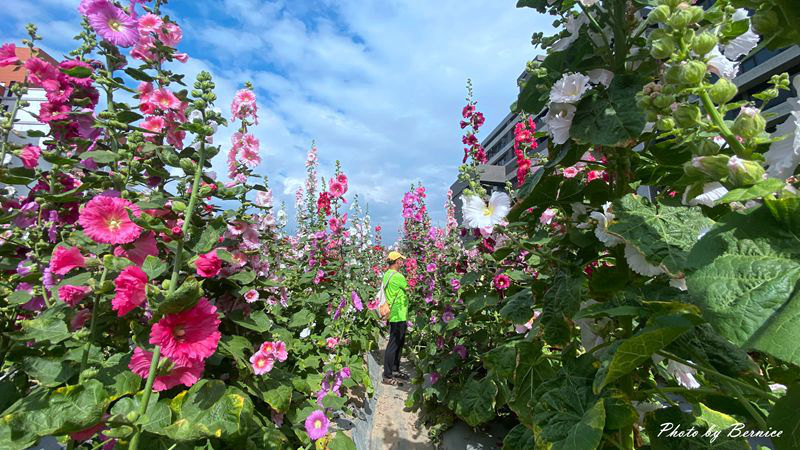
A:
383,251,409,384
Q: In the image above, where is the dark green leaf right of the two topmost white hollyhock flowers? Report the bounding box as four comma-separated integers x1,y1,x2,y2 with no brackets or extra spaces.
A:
570,74,646,147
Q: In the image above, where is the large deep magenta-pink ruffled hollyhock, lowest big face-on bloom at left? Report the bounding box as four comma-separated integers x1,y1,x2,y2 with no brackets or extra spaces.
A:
150,298,222,365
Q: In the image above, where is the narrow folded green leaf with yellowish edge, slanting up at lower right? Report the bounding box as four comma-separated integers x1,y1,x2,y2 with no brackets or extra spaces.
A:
594,316,694,393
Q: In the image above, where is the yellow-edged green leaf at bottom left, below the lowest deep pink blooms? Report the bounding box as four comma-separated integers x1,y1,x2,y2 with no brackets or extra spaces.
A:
163,379,253,441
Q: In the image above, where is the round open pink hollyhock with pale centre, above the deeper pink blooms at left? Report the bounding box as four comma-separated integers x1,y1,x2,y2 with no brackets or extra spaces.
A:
78,195,142,244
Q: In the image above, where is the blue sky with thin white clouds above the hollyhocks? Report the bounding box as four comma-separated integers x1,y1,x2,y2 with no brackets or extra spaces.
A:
0,0,552,242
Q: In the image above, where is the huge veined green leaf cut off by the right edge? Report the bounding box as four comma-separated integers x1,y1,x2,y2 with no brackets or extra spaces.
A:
687,207,800,364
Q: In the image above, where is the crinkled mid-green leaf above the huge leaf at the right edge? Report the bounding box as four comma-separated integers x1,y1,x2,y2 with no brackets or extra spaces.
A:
609,194,714,274
